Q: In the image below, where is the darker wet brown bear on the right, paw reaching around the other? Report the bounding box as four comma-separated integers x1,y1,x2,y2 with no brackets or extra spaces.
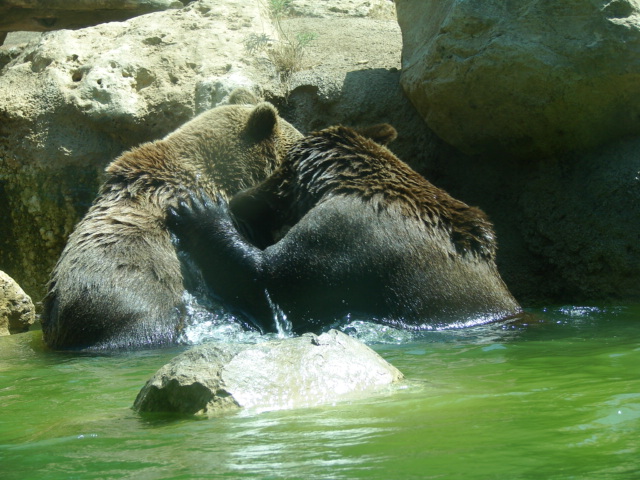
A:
169,125,521,332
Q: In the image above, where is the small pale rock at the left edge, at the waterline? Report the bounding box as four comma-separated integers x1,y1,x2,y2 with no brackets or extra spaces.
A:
0,271,36,336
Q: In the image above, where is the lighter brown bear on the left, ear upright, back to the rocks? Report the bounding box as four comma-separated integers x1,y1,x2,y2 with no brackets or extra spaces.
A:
42,90,302,349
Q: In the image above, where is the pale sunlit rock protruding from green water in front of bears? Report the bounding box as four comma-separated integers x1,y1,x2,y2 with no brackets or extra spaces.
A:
134,330,403,414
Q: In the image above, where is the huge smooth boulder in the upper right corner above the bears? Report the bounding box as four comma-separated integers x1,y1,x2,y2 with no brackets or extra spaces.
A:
396,0,640,157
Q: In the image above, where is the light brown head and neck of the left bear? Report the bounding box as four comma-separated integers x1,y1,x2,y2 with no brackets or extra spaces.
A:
107,89,302,202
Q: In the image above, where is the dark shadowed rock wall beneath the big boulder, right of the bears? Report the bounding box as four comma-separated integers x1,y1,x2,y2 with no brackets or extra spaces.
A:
429,138,640,306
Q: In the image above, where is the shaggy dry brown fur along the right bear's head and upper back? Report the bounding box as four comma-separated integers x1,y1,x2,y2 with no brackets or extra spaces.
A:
290,124,497,259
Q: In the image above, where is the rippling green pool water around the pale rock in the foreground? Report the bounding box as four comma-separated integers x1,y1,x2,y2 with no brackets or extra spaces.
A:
0,305,640,480
